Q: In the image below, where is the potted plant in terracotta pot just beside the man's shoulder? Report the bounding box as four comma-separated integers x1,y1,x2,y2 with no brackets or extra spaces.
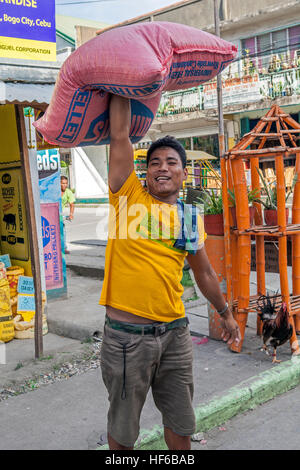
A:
198,190,224,235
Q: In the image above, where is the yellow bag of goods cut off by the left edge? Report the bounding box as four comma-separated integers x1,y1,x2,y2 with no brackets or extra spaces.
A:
0,278,15,343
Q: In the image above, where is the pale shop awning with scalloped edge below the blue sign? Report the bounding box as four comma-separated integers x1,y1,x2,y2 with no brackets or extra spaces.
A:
0,81,54,108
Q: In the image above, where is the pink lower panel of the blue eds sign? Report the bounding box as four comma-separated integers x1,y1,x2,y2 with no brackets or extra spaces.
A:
41,202,64,291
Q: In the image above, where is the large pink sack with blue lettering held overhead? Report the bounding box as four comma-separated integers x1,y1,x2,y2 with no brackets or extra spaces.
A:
34,22,237,147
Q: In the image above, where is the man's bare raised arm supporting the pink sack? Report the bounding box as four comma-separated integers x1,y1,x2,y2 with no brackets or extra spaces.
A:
108,95,134,193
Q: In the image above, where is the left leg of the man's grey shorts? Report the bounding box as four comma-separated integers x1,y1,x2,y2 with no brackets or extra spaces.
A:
101,325,157,447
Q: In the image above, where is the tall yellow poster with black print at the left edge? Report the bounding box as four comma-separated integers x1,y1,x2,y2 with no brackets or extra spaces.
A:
0,168,29,261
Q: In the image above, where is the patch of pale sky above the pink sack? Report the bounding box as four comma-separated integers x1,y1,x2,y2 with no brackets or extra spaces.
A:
55,0,179,24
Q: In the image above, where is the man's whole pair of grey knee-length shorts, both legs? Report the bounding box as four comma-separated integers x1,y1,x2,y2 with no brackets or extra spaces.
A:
101,325,195,447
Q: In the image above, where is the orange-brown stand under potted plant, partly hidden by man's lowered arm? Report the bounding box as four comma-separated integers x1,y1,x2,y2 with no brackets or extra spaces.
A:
205,235,227,340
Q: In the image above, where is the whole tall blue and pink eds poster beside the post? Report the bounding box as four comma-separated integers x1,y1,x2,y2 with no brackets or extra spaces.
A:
37,149,67,298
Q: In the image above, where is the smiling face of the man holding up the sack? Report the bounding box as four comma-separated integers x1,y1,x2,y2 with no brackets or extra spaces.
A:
146,147,187,204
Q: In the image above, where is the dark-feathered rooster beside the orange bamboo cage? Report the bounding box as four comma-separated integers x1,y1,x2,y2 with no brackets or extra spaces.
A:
258,295,293,363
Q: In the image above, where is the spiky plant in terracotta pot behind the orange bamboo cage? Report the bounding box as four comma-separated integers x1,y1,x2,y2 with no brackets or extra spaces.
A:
254,168,297,225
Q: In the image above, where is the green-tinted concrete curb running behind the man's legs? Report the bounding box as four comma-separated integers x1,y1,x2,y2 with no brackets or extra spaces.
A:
97,356,300,450
